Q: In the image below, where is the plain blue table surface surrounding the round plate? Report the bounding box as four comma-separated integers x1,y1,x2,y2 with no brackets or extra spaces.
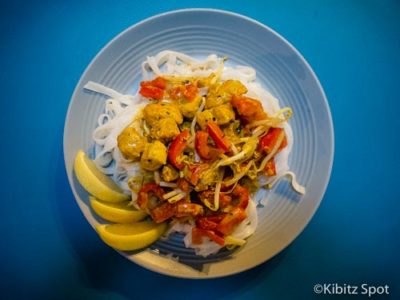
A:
0,0,400,299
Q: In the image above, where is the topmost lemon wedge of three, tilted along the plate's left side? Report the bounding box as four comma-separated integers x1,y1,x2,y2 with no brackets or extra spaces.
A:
74,150,129,202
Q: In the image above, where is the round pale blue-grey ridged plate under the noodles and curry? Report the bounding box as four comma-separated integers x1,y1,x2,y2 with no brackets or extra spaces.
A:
64,9,333,278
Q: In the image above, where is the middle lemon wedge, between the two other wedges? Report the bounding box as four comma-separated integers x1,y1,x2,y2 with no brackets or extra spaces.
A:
89,196,147,223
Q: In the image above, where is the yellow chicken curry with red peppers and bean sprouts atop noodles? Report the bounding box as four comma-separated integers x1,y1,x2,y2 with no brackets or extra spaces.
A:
118,73,289,246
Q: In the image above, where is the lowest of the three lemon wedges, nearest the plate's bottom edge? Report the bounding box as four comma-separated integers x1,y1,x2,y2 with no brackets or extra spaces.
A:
96,221,167,251
